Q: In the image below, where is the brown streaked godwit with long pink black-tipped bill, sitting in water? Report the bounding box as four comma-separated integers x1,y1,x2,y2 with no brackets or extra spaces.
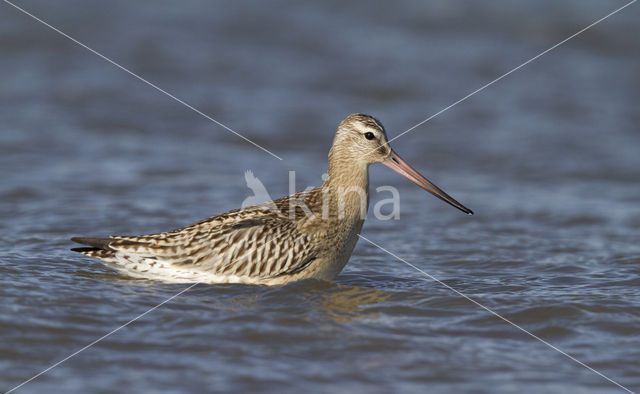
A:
72,114,473,285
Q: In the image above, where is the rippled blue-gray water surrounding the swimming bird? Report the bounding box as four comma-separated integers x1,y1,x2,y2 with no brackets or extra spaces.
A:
0,0,640,393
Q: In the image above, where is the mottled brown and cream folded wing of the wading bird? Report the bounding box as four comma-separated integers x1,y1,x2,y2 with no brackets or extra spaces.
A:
103,215,316,278
